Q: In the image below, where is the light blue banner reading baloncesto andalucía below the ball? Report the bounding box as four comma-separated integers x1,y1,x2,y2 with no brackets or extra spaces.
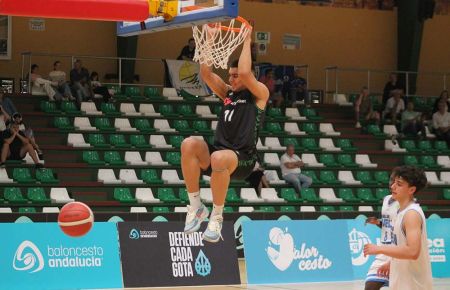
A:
0,223,123,290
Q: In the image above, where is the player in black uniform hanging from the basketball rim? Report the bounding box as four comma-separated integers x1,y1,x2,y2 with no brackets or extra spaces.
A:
181,33,269,242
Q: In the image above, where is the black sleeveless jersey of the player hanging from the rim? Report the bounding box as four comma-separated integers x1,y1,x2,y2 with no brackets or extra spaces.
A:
214,90,265,154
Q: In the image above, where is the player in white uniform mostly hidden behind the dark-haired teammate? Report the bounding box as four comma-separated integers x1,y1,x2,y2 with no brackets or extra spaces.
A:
364,169,399,290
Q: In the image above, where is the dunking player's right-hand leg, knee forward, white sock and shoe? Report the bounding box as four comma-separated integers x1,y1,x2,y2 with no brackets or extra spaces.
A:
203,150,238,243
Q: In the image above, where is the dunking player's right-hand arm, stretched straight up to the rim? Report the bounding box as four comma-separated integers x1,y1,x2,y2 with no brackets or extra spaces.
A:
238,31,269,109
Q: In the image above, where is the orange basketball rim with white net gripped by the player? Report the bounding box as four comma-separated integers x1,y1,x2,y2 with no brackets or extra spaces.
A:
192,16,252,69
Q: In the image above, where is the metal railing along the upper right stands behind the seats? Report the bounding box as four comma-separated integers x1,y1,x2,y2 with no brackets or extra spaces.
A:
325,66,450,96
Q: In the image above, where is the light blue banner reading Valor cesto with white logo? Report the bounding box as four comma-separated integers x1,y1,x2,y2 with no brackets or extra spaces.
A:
243,220,353,284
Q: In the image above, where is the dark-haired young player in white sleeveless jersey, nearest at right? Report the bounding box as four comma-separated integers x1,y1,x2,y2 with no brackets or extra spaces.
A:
364,166,433,290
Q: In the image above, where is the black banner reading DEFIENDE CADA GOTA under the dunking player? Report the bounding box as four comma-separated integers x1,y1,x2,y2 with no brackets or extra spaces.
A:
118,222,240,287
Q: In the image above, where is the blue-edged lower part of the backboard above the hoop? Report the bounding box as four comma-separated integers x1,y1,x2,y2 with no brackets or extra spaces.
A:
117,0,239,36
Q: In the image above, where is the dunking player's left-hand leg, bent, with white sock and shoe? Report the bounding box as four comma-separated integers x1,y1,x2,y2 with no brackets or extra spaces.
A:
181,137,210,234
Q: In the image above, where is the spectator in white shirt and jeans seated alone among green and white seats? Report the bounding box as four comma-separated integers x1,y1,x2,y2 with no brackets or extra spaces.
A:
280,144,312,193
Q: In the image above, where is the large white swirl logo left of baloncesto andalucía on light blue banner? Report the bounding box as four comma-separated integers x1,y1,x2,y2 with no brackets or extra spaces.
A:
13,241,44,273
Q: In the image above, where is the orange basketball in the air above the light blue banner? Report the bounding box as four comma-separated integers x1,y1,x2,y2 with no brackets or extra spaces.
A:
58,201,94,237
